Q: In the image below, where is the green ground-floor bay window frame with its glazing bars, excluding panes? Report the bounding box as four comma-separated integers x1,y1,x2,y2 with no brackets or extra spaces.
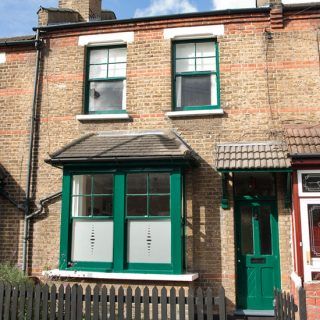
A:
59,168,184,274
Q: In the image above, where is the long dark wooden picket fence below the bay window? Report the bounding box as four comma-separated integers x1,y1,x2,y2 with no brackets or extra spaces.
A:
0,282,226,320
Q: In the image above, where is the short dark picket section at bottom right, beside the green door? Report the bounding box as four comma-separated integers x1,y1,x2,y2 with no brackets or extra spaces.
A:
274,287,307,320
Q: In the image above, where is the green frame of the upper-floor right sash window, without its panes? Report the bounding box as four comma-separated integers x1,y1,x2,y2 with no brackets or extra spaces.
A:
172,39,220,111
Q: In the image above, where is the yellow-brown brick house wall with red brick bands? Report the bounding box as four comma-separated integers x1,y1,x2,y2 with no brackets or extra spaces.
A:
0,6,320,307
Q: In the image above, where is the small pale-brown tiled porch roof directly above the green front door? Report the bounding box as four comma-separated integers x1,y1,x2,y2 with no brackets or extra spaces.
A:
216,141,290,170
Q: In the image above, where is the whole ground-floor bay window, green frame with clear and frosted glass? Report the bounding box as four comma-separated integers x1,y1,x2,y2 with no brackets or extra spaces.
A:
60,169,183,274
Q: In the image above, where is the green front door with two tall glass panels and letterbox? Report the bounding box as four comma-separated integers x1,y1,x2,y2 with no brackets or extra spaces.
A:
235,200,280,310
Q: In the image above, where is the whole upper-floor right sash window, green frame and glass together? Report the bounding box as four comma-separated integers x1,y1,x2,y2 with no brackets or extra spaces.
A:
172,39,220,111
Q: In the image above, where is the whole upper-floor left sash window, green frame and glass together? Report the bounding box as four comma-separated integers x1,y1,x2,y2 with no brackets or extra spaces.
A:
85,46,127,114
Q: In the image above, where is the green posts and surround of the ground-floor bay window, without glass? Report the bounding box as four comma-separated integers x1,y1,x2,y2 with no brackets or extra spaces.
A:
59,168,184,274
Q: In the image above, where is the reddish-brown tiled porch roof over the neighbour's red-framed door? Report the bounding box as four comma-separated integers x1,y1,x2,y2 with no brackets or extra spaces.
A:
285,125,320,156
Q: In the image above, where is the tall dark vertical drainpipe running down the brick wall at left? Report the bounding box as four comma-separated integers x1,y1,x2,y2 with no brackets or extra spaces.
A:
22,30,41,273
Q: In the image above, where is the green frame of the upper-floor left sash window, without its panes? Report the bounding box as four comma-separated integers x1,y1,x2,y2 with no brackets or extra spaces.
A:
84,45,127,114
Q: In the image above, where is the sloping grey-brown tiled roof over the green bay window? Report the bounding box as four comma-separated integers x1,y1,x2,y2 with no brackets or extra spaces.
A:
46,131,196,164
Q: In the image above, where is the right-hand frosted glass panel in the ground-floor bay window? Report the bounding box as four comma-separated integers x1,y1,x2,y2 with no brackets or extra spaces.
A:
128,220,171,263
